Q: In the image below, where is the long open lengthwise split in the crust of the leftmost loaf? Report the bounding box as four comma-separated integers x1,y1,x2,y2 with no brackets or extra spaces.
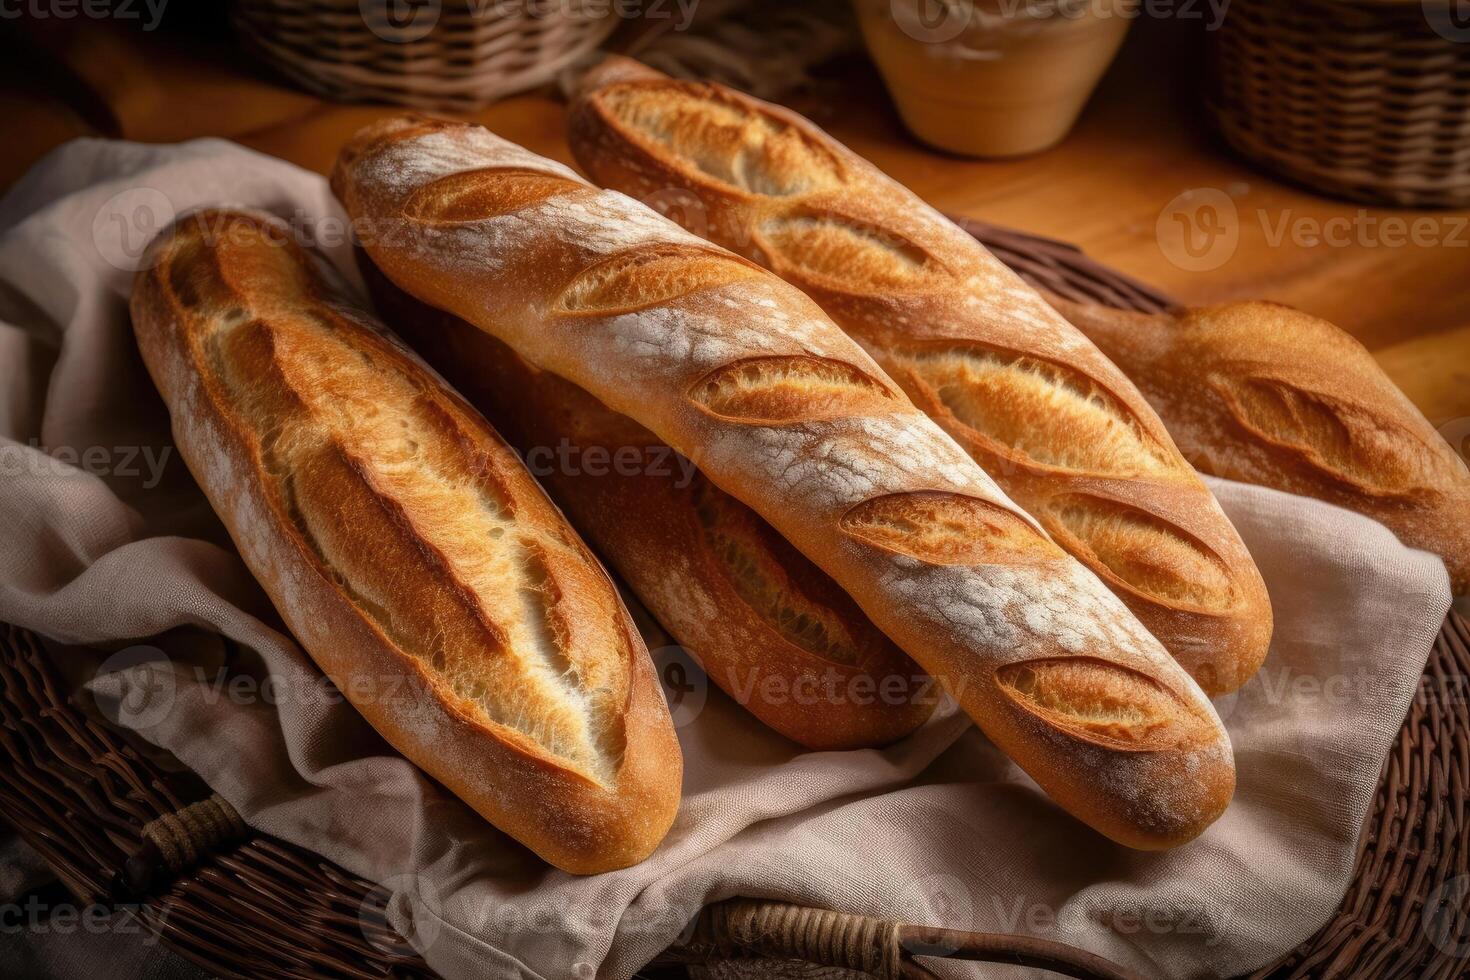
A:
166,218,631,786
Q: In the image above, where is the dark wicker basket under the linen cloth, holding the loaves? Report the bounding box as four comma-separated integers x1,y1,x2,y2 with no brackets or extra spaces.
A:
0,220,1470,980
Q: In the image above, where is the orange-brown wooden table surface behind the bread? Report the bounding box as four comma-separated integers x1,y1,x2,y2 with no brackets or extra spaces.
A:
0,14,1470,432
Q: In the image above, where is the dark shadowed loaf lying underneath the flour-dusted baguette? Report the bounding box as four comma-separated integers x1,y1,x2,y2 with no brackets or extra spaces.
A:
359,251,939,749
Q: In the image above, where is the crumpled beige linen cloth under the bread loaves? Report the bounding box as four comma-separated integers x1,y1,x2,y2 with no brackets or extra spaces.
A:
0,140,1449,979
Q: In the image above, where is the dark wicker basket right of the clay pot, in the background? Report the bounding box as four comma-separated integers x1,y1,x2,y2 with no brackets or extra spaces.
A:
1208,0,1470,207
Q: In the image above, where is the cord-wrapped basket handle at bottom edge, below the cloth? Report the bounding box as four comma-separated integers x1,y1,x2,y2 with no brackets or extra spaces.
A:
670,898,1139,980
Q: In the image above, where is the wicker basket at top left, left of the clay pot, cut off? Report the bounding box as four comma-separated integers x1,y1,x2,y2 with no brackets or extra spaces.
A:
231,0,617,112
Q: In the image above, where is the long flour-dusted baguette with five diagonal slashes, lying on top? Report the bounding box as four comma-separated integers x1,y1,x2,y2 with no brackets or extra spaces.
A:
332,116,1235,848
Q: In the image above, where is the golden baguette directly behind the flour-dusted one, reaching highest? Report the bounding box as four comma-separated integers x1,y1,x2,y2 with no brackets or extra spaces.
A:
567,57,1272,693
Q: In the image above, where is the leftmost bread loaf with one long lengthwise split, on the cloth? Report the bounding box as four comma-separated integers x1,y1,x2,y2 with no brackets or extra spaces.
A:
132,212,681,873
